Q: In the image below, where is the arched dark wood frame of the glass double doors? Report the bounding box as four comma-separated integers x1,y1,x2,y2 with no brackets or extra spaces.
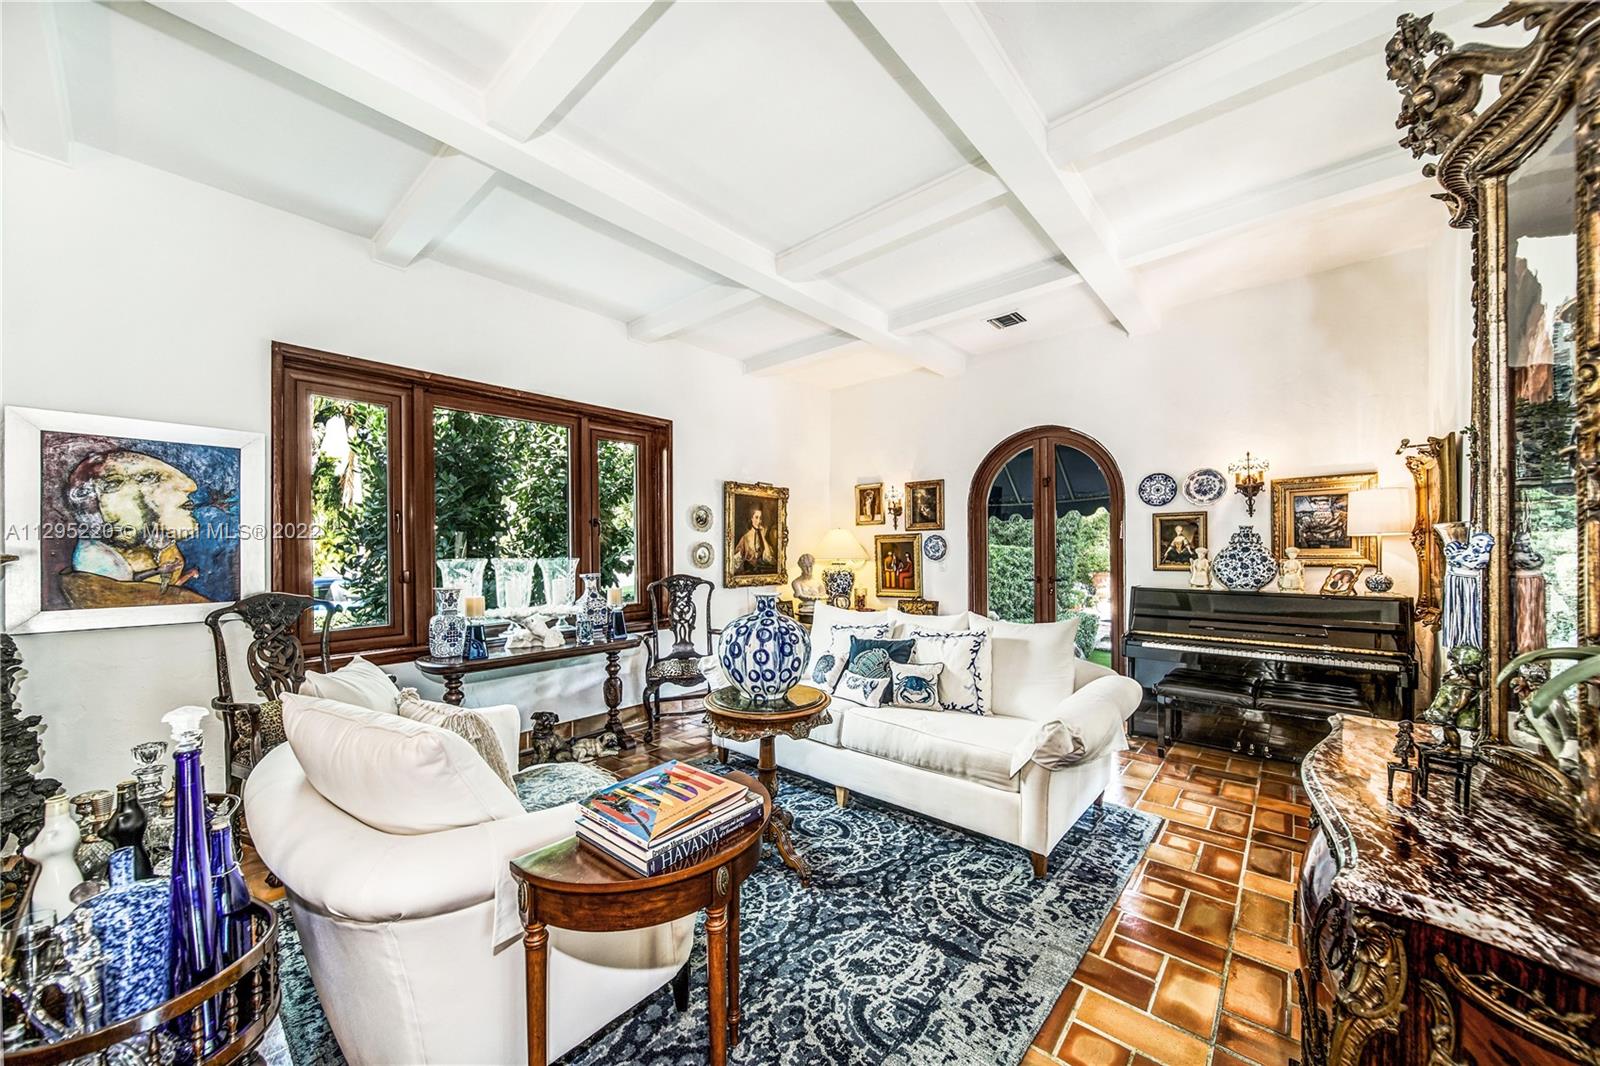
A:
966,426,1126,672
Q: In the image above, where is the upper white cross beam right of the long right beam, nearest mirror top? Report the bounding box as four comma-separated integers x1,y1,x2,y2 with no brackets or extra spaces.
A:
1048,3,1467,166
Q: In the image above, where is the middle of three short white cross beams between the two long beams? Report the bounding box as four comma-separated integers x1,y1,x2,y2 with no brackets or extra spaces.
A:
778,166,1006,279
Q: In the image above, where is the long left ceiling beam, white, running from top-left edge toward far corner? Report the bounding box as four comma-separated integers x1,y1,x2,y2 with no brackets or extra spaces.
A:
155,0,966,375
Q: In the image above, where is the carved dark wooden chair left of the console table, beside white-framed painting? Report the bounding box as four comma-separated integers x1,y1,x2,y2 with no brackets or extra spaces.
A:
205,592,339,795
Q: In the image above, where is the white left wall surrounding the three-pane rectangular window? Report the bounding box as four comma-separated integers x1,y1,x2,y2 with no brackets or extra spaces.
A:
0,146,829,791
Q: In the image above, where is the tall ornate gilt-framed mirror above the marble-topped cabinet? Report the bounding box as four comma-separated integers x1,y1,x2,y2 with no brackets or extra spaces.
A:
1387,3,1600,831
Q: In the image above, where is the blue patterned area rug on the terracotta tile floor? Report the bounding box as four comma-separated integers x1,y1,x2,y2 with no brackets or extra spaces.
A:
268,760,1160,1066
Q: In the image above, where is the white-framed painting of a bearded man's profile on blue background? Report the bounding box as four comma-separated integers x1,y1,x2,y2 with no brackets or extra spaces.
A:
5,407,267,632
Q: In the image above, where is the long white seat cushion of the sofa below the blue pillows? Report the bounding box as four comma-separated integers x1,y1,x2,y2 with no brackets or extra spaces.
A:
835,704,1038,792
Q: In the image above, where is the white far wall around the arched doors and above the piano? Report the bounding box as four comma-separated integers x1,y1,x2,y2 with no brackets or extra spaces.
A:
832,251,1438,611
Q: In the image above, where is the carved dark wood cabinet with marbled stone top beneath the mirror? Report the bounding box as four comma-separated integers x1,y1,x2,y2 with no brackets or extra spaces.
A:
1294,715,1600,1066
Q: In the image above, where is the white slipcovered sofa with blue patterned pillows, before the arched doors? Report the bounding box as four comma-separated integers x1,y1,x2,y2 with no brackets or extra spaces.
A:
718,603,1141,877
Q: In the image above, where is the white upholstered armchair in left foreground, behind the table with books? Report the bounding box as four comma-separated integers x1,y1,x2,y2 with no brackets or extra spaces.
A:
245,675,694,1066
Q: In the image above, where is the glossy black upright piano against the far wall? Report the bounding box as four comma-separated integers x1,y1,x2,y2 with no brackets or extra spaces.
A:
1123,587,1418,760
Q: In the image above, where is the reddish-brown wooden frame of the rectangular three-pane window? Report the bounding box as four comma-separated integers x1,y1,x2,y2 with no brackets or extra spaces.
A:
270,341,672,663
